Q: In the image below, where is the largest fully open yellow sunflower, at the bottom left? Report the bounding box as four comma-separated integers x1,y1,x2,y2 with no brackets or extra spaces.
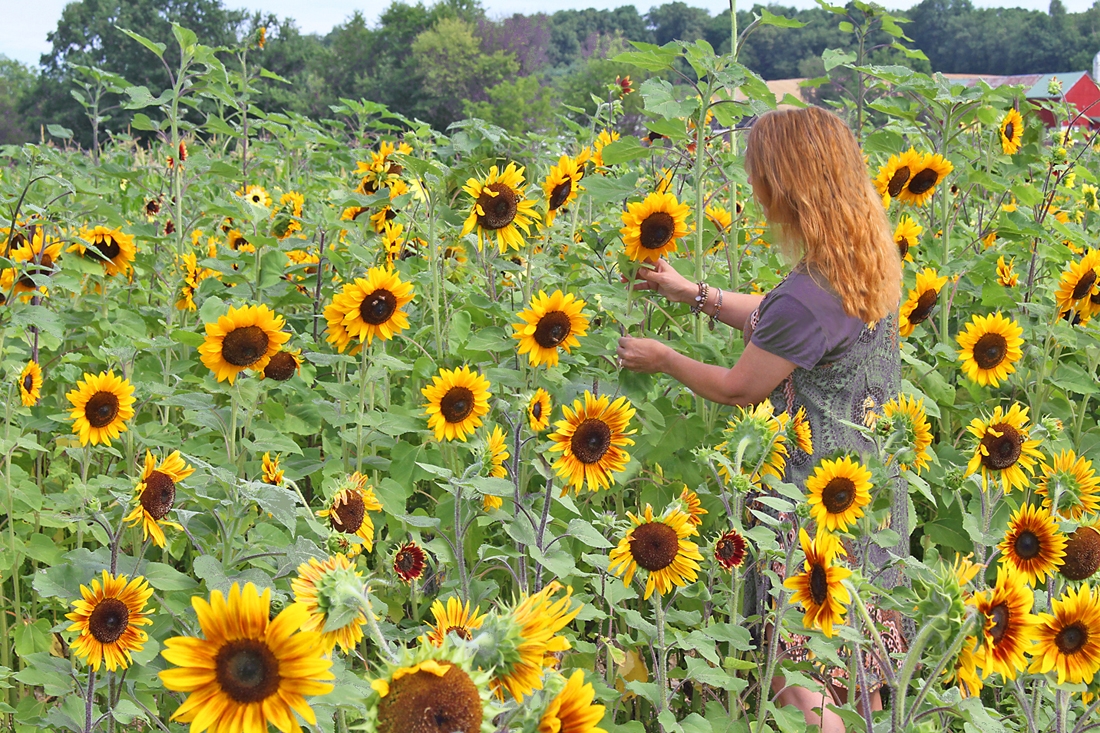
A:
160,583,333,733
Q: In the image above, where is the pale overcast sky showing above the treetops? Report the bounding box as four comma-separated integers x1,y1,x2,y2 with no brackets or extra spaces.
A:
0,0,1096,64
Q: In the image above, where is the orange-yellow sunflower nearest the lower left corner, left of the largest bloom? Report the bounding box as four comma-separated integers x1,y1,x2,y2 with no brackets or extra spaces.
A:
65,570,153,671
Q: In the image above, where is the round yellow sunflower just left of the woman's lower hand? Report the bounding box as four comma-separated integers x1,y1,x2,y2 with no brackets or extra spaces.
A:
512,291,589,367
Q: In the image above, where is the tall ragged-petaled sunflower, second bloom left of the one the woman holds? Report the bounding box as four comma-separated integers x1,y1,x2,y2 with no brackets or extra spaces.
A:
461,163,539,254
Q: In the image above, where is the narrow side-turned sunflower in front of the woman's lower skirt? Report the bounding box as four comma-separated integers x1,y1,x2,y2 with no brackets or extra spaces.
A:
783,529,851,636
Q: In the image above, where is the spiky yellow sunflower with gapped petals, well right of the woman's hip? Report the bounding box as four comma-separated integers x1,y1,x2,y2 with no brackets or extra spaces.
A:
966,403,1043,493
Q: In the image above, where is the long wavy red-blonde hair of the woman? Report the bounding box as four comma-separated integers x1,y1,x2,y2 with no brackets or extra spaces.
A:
745,107,901,322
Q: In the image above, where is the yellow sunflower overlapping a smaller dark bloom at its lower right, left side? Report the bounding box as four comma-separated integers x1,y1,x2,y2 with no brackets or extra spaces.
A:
199,305,290,384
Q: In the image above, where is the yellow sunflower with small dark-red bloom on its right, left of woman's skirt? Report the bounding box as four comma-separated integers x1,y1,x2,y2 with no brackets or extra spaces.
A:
607,504,703,600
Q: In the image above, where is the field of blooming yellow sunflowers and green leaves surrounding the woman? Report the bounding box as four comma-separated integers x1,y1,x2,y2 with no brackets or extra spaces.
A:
0,2,1100,733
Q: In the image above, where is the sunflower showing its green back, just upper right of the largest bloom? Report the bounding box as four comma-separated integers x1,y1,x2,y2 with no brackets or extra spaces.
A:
290,555,366,654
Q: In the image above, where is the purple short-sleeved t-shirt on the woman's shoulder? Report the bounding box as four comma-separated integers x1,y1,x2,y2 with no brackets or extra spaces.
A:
746,270,865,369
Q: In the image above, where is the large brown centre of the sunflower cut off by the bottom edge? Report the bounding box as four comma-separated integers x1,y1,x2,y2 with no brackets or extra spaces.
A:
377,665,483,733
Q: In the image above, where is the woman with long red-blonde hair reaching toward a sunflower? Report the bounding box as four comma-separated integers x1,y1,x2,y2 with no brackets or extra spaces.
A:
618,107,909,733
